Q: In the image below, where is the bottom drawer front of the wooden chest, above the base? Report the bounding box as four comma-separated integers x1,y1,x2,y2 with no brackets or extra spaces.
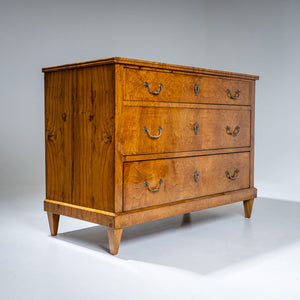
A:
124,152,249,211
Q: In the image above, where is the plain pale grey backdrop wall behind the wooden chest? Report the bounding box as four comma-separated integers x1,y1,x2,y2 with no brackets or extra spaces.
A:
0,0,300,201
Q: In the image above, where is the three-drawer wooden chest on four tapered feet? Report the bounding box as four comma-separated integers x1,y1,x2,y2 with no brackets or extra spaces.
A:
43,57,258,254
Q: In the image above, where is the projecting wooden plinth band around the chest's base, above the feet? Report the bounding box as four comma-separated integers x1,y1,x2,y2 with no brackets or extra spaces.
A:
44,188,257,228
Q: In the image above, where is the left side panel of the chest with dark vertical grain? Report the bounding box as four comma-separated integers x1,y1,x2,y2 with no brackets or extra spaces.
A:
45,65,115,211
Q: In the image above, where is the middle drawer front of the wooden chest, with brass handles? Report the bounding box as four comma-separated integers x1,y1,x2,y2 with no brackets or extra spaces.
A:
123,106,250,155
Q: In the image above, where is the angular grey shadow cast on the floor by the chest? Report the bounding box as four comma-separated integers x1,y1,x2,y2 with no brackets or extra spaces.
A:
57,198,300,274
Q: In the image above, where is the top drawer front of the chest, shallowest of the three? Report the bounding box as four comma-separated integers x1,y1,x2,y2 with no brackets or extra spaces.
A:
125,69,250,105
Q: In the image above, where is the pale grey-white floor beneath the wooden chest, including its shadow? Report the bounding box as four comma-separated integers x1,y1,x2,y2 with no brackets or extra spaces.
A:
0,187,300,300
